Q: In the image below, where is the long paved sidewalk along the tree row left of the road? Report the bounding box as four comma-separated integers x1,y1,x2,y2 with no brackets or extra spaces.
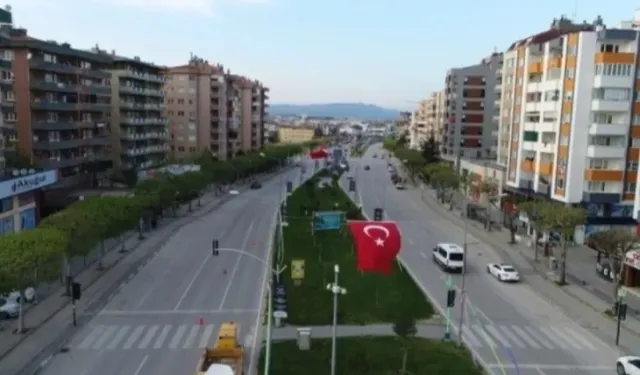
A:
0,170,285,375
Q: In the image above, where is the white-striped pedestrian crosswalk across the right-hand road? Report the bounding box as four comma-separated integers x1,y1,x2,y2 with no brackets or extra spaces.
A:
462,324,599,350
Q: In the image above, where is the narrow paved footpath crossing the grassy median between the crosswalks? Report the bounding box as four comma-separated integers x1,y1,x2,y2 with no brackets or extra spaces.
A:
265,323,445,341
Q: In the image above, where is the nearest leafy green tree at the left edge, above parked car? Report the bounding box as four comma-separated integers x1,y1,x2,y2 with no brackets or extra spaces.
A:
0,228,69,333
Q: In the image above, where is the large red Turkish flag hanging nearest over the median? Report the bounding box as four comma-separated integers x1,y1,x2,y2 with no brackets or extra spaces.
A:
347,220,402,275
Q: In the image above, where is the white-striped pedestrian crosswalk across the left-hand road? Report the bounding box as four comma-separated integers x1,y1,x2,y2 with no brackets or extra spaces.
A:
72,324,220,350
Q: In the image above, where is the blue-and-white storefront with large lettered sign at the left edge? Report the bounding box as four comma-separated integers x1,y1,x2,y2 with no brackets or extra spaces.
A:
0,170,58,236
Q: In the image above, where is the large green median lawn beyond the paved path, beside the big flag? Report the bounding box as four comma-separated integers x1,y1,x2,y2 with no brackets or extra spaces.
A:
282,172,433,325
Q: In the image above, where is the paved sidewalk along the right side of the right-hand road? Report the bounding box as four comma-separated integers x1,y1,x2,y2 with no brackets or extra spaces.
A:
416,188,640,353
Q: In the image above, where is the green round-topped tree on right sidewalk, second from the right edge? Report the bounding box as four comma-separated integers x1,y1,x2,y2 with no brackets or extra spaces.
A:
539,202,587,285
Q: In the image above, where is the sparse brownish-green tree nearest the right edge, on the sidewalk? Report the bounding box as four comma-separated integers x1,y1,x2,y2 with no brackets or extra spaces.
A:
589,228,640,308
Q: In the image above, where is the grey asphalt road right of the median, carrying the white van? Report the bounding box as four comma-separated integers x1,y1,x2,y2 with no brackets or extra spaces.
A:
343,144,619,375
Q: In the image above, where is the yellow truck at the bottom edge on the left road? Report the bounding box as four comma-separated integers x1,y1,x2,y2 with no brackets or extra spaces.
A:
195,321,244,375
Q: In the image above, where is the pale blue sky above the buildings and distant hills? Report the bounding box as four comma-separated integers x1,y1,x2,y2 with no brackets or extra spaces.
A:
9,0,636,110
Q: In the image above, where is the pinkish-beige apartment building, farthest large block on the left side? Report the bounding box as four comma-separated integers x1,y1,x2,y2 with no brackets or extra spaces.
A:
164,56,268,160
